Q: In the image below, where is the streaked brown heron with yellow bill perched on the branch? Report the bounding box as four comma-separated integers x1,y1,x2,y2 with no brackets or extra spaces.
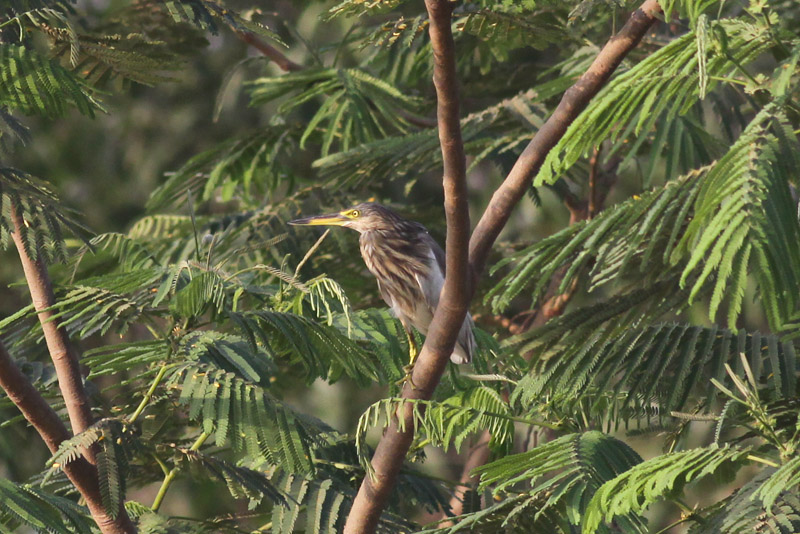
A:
289,202,476,386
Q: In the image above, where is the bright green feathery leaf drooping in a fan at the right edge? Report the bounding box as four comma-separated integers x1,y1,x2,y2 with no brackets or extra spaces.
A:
672,105,800,330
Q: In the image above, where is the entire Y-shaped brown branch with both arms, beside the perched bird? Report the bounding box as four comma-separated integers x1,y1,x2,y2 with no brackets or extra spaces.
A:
344,0,661,534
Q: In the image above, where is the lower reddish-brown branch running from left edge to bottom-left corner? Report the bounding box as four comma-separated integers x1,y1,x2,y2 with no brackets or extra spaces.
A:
0,341,136,534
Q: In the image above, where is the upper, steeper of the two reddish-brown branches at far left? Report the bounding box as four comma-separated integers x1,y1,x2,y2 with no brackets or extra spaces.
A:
11,205,93,440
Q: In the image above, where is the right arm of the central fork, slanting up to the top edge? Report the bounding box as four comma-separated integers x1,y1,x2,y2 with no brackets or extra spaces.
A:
469,0,661,277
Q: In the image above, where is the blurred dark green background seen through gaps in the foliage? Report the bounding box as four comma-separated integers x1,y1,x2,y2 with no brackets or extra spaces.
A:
0,0,780,532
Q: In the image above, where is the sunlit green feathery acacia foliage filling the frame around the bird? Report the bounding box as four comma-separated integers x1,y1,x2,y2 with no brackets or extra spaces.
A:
0,0,800,533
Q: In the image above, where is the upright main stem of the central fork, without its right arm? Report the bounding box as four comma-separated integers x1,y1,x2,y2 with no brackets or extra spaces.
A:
344,0,470,534
